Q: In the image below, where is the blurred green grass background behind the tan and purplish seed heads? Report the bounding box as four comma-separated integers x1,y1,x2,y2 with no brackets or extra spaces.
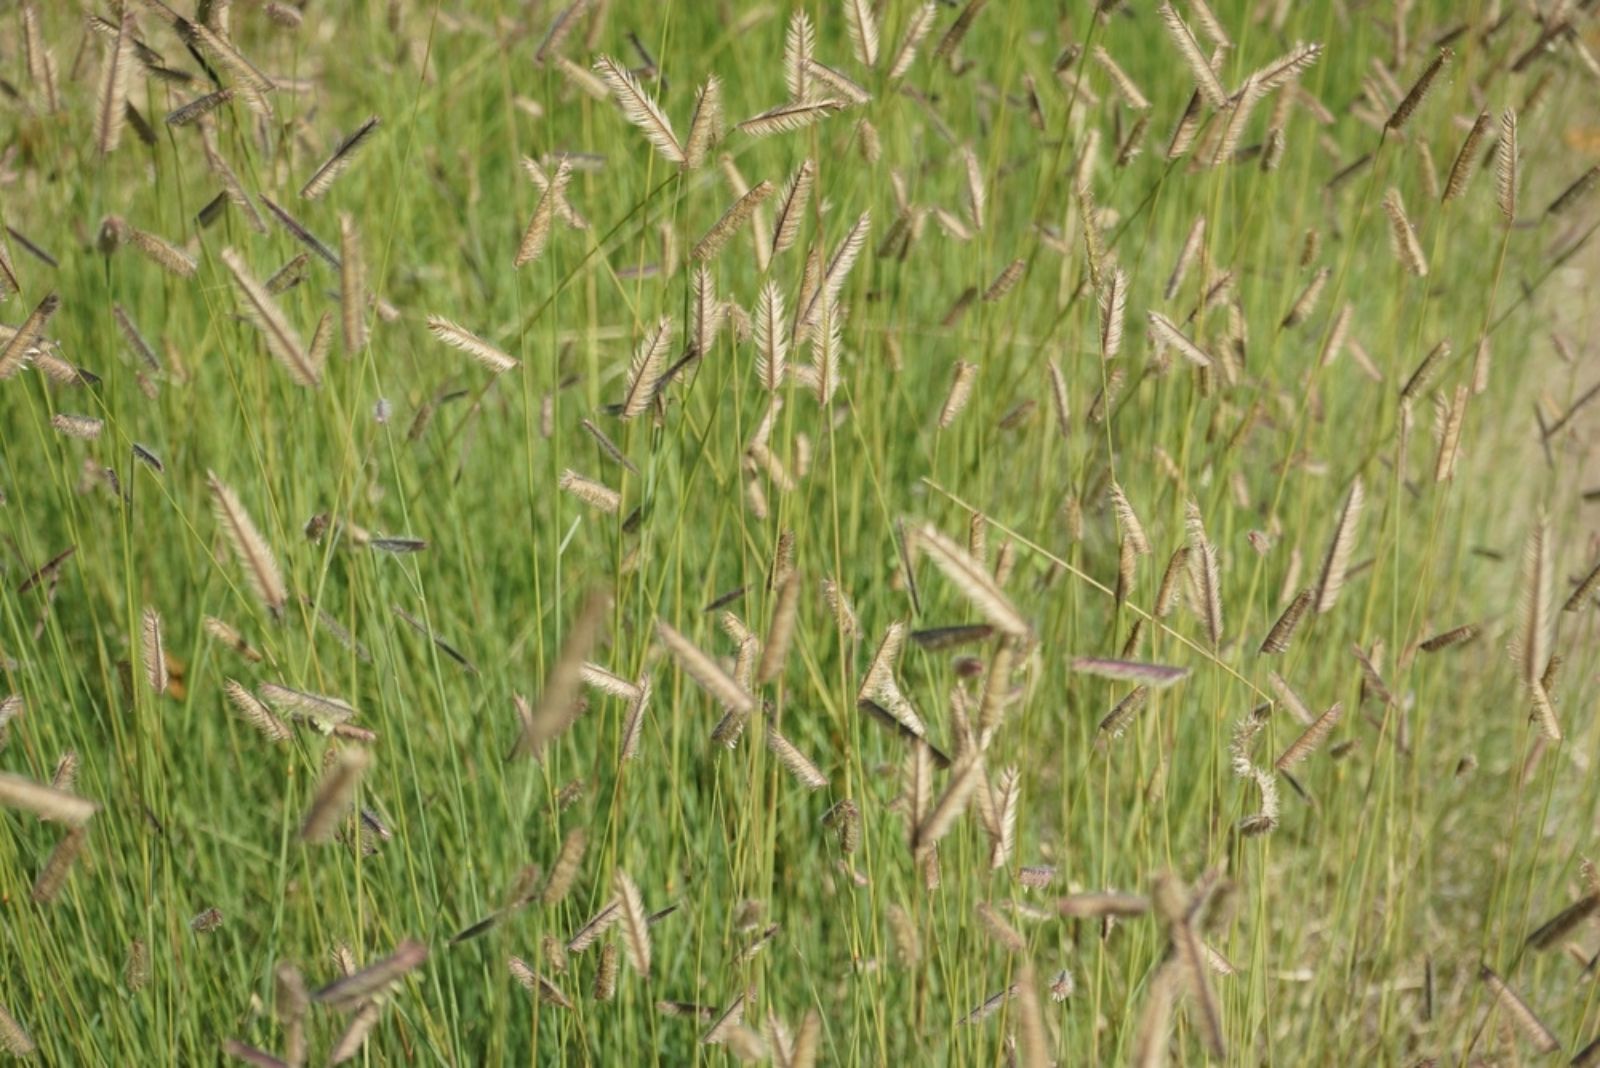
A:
0,0,1600,1065
